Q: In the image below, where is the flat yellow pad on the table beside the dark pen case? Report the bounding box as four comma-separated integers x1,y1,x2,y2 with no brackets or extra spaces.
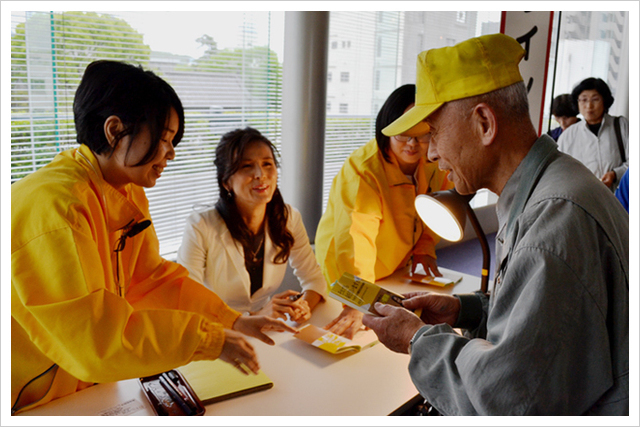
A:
178,360,273,405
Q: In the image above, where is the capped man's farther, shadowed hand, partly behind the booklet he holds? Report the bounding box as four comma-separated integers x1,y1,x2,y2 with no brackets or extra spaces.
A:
402,292,460,327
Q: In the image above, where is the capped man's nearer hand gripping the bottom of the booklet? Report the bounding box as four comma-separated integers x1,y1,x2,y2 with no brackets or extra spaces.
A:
362,302,424,353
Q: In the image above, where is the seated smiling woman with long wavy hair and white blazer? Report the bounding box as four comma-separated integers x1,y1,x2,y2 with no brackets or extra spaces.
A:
178,127,326,322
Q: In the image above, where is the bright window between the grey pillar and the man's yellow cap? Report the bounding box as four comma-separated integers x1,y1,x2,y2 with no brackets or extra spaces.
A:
322,11,500,210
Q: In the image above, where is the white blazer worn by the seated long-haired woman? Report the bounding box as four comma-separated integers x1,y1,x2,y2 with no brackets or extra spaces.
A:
177,205,327,312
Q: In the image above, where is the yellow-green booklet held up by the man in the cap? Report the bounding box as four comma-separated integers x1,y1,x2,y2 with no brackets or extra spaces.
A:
329,273,405,316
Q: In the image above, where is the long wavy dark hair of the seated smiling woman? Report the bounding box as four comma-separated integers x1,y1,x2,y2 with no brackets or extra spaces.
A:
214,127,294,264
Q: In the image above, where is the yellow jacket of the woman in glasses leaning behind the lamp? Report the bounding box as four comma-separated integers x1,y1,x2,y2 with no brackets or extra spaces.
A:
315,139,453,284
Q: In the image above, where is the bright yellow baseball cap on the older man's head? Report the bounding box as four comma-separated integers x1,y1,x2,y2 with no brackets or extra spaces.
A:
382,34,525,136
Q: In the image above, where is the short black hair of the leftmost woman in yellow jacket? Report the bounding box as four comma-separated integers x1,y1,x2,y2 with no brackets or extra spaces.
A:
73,60,184,166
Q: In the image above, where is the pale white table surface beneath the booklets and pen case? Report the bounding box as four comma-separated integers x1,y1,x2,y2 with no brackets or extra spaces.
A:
19,268,480,416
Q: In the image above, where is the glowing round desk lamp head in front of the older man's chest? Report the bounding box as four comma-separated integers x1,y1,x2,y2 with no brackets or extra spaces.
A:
414,189,473,242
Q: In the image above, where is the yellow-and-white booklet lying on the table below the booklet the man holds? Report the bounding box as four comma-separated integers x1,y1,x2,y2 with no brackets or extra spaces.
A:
293,324,379,354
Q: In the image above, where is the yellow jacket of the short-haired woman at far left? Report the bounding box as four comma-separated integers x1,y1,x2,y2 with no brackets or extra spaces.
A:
11,145,239,412
